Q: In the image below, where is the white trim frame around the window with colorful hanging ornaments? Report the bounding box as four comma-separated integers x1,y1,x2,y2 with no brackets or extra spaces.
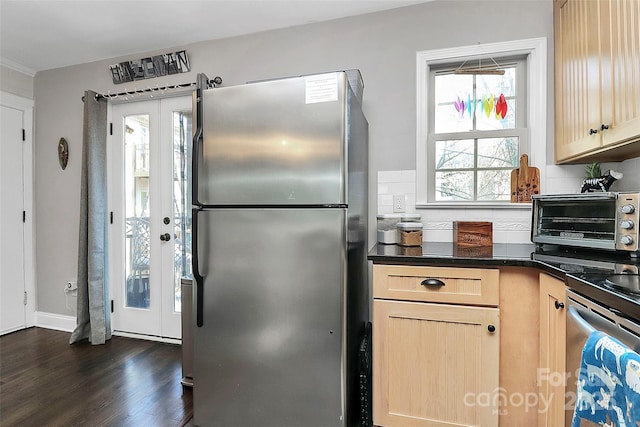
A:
416,37,547,209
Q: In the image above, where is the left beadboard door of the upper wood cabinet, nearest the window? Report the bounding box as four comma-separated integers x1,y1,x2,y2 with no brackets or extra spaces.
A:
554,0,602,161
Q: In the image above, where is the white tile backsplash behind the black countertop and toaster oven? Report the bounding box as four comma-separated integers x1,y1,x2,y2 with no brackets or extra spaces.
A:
377,157,640,243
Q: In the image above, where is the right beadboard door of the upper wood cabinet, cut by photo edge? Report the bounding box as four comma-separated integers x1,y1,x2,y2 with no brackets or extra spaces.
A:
599,0,640,150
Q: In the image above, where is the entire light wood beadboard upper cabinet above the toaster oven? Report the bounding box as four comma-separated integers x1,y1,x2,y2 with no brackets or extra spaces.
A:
554,0,640,163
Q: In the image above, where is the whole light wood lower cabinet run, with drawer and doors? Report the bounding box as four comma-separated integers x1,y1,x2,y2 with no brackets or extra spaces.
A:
373,264,566,427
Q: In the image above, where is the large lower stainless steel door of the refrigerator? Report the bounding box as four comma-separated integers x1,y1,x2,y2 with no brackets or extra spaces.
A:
193,208,346,427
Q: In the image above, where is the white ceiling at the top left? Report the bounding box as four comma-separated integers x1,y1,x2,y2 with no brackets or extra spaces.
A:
0,0,424,74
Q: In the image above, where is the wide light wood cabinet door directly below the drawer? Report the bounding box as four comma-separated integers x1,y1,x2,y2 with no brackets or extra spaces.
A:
373,299,504,427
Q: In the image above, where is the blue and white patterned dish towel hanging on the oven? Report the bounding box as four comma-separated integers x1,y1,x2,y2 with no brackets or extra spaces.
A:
571,331,640,427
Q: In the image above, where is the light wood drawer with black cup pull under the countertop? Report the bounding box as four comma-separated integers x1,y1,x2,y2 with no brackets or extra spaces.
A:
373,265,500,306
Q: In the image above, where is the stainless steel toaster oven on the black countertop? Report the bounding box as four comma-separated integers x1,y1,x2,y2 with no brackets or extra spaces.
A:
531,192,640,257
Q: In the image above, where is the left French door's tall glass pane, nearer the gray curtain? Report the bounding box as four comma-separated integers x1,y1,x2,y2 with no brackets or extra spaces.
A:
124,114,151,308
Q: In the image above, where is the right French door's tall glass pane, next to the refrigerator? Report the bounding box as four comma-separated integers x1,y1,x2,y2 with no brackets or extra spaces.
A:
172,111,191,312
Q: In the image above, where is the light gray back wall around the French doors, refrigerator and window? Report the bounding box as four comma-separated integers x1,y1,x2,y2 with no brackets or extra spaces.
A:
34,0,553,315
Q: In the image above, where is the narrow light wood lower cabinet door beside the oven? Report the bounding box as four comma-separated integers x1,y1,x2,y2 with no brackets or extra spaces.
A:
538,273,567,427
